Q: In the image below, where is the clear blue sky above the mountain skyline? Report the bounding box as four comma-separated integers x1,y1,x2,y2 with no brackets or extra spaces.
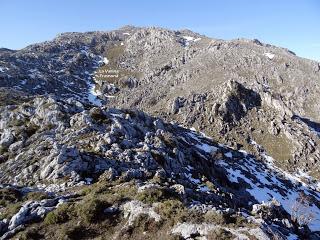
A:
0,0,320,61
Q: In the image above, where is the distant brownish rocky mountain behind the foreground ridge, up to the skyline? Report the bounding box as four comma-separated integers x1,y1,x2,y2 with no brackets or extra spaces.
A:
0,26,320,178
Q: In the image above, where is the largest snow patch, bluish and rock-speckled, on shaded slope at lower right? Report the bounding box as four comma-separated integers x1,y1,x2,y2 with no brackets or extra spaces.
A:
218,155,320,231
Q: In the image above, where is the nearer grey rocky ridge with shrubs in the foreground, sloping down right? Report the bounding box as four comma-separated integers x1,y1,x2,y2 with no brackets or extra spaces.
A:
0,94,320,239
